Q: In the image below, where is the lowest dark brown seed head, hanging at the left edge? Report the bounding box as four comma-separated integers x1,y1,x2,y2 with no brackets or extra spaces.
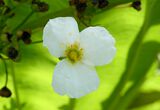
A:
0,86,12,98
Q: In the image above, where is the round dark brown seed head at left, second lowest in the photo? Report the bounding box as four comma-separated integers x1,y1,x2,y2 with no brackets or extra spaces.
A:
7,47,18,60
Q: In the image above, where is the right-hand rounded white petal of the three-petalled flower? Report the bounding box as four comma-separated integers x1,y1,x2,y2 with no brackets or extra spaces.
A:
80,26,116,66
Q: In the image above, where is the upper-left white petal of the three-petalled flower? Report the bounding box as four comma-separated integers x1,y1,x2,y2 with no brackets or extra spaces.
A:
43,17,79,57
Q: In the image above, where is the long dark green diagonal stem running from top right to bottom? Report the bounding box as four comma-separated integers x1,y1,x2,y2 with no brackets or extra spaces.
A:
103,0,158,110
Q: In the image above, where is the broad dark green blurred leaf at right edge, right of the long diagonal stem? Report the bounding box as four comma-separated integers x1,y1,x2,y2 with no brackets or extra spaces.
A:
114,42,160,110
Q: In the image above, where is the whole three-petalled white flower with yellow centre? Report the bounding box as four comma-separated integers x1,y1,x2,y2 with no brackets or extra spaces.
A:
43,17,116,98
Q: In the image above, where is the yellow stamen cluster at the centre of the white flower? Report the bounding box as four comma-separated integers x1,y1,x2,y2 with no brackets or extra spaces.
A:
65,43,83,63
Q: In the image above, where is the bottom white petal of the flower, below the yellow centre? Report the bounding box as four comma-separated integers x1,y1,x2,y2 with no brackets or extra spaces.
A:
52,60,99,98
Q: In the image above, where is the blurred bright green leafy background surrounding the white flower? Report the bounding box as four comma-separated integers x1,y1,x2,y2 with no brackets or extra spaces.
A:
0,0,160,110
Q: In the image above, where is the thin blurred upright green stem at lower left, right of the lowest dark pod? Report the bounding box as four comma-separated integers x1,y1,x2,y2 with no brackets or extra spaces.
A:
11,61,21,110
